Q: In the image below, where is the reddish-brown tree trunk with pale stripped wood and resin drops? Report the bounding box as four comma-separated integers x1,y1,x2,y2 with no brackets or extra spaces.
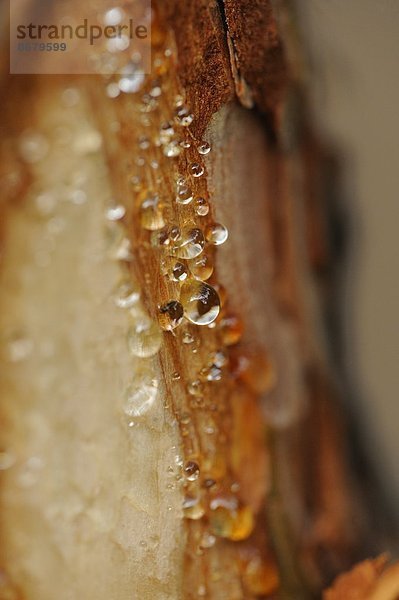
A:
0,0,384,600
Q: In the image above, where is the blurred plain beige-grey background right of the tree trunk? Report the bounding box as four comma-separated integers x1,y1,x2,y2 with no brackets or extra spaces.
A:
295,0,399,510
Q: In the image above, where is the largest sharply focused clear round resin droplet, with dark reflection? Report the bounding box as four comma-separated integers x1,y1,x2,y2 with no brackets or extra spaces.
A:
180,281,220,325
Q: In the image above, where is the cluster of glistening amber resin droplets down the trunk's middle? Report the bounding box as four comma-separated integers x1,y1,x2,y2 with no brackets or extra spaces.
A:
103,11,278,596
